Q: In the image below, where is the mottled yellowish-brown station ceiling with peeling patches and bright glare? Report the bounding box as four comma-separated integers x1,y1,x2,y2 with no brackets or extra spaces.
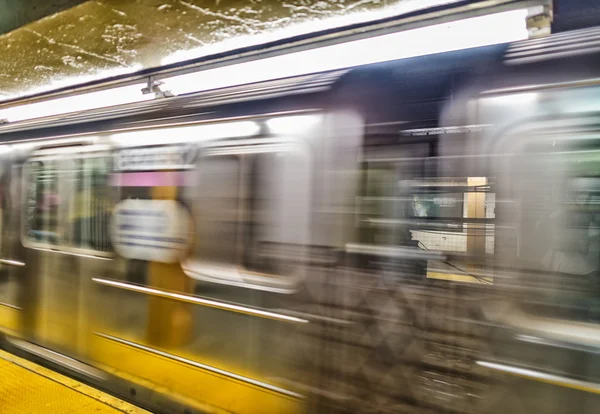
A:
0,0,428,101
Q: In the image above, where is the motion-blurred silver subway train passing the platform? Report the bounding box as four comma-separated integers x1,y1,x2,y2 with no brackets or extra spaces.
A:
0,28,600,413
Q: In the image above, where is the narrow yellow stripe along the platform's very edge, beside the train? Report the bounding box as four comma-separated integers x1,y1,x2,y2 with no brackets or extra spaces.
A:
0,350,150,414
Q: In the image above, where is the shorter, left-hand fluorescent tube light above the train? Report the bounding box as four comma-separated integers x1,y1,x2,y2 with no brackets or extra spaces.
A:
0,84,154,122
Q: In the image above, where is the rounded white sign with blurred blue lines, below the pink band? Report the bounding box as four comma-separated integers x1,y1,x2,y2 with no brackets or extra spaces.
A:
112,200,193,263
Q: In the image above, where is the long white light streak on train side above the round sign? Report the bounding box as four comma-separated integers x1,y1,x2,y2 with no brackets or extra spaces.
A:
110,121,260,147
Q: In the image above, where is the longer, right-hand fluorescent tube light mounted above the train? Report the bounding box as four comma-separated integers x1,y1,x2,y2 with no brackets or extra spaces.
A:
163,10,528,94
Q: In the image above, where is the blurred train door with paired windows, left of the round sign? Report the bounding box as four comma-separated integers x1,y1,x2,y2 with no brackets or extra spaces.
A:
21,146,111,357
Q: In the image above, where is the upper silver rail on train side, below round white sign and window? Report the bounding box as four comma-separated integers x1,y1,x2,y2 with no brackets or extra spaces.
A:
92,277,309,323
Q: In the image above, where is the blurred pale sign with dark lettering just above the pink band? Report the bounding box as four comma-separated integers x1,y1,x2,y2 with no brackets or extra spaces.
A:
115,145,196,171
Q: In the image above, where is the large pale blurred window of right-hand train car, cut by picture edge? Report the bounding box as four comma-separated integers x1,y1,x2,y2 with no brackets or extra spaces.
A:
497,126,600,324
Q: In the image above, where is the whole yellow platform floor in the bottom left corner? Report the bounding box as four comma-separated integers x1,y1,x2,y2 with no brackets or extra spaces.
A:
0,351,148,414
